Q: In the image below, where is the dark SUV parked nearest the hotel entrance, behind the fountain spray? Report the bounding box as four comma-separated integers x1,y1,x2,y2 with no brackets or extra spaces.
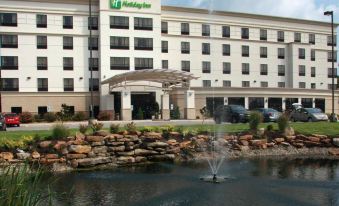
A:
214,105,249,124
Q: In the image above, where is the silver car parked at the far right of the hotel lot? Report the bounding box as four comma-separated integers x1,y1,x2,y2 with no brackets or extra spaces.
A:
290,108,328,122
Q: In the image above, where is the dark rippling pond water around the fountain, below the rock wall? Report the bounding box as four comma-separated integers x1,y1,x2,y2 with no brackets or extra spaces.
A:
52,159,339,206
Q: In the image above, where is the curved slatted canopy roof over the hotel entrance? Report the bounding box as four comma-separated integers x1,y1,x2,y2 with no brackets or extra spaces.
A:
101,69,198,88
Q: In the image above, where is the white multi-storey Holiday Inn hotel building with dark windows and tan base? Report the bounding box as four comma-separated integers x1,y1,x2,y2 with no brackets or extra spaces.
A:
0,0,339,120
